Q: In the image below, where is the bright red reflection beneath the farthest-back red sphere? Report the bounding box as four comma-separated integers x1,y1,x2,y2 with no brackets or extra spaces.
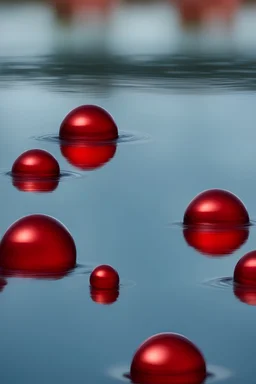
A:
60,144,116,170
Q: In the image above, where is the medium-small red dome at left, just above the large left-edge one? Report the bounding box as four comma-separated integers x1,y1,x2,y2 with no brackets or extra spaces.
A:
12,149,60,178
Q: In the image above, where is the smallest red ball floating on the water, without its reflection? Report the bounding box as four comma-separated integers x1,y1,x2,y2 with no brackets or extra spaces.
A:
90,265,119,289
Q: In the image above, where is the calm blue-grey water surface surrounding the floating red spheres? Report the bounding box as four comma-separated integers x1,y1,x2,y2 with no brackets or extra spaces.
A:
0,4,256,384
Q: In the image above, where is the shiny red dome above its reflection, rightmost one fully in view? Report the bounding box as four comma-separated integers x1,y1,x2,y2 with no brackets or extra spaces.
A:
183,189,249,226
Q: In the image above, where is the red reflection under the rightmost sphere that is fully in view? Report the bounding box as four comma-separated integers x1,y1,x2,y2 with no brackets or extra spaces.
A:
183,227,249,257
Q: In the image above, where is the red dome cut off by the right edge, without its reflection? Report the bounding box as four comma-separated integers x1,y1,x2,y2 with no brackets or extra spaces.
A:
234,251,256,287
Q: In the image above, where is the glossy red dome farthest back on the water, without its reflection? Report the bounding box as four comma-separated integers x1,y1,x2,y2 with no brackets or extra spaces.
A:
59,105,118,141
